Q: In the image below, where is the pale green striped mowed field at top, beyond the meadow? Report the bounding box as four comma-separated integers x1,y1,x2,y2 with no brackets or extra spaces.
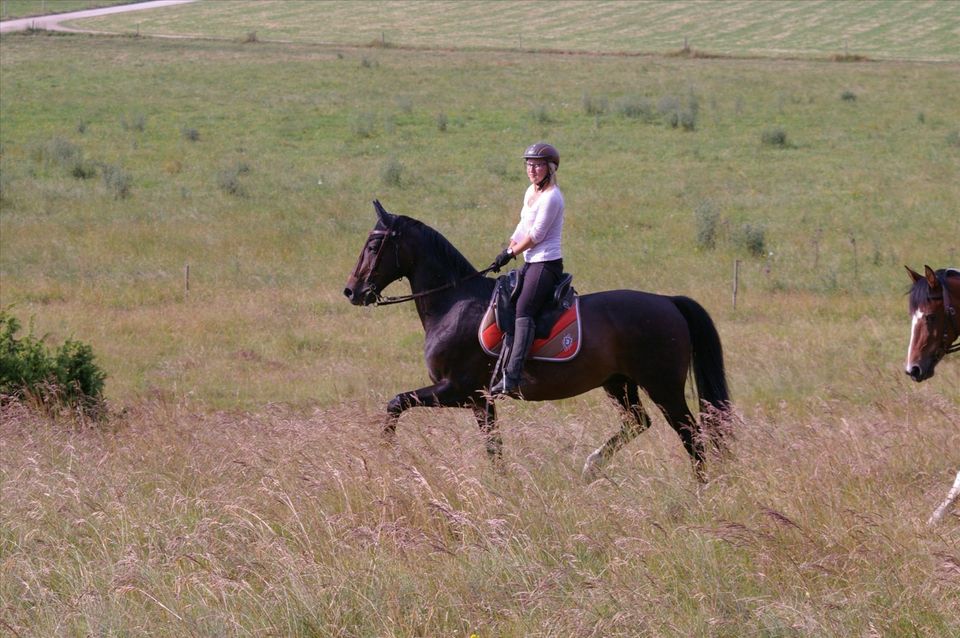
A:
65,0,960,61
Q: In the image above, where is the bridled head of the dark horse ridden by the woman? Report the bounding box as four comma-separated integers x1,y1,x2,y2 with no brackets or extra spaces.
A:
343,201,403,306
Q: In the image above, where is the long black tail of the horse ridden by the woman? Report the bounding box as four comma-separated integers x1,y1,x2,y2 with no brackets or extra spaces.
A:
670,297,730,414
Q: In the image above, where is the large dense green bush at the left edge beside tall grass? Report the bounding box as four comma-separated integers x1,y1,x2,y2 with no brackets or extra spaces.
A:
0,311,107,413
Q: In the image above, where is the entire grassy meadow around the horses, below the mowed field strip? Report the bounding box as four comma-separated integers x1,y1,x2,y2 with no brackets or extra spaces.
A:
0,2,960,638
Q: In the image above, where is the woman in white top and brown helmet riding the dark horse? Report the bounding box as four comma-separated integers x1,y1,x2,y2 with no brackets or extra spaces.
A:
490,142,564,396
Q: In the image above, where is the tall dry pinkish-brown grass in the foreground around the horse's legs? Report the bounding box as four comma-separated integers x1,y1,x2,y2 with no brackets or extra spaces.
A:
0,392,960,636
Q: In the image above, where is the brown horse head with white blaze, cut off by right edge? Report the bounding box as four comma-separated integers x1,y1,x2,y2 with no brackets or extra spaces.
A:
905,266,960,382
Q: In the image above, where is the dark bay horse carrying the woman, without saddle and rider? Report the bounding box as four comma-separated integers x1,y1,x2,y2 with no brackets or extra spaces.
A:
343,202,730,480
